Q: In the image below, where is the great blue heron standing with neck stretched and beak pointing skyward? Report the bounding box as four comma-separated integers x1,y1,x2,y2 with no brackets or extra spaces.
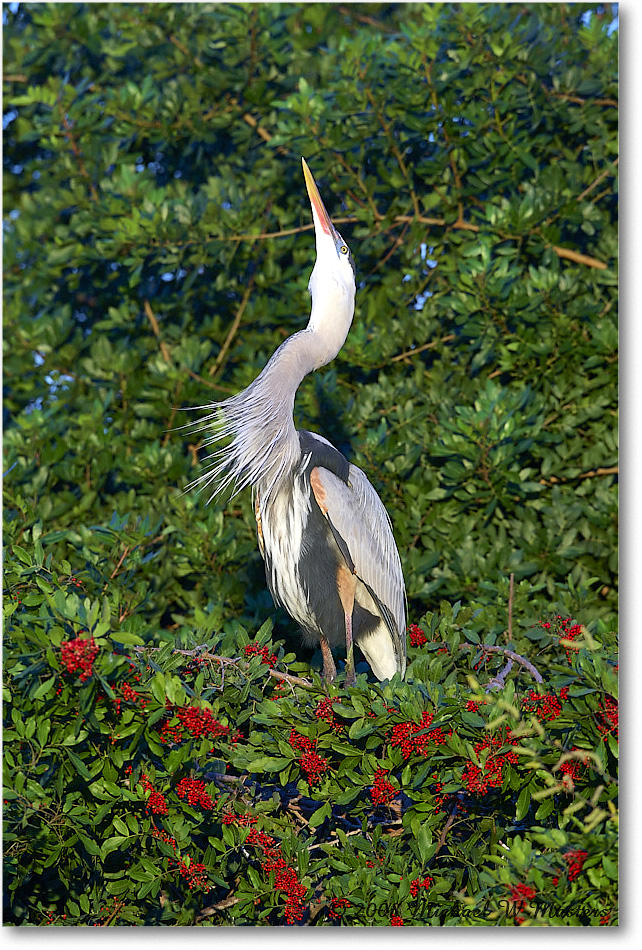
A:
188,159,406,685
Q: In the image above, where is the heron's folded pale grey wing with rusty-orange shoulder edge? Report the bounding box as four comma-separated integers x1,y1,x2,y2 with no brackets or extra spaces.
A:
310,465,406,671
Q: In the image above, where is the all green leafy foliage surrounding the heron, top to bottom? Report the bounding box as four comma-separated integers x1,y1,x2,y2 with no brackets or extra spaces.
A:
3,3,617,925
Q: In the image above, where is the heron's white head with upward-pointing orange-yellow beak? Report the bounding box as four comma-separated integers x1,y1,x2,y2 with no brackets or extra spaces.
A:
301,158,356,310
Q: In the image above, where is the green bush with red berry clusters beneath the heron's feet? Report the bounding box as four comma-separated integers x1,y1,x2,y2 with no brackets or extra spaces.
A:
4,530,618,926
